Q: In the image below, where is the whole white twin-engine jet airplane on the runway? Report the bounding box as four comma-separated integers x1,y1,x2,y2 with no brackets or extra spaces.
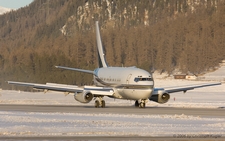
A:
8,21,221,108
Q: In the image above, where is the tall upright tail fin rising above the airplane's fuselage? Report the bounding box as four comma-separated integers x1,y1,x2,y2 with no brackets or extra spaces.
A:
96,21,108,68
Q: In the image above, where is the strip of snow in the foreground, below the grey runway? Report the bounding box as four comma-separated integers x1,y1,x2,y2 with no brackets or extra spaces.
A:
0,112,225,136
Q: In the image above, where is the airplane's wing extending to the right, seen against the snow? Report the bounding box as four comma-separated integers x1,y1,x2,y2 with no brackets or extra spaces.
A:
155,83,221,94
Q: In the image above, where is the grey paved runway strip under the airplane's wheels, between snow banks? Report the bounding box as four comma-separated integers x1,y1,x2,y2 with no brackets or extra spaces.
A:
0,104,225,118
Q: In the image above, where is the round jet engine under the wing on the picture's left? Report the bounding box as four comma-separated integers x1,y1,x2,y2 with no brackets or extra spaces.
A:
74,91,93,103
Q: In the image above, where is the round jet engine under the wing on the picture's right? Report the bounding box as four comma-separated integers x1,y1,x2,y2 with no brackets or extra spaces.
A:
149,90,170,104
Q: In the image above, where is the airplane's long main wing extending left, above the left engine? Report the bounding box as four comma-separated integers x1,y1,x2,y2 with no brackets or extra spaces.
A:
8,81,114,96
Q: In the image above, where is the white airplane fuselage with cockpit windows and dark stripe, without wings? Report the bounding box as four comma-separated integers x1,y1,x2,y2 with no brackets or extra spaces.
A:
94,67,154,100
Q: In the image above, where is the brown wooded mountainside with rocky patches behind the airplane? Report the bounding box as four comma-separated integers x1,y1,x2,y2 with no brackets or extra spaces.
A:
0,0,225,89
